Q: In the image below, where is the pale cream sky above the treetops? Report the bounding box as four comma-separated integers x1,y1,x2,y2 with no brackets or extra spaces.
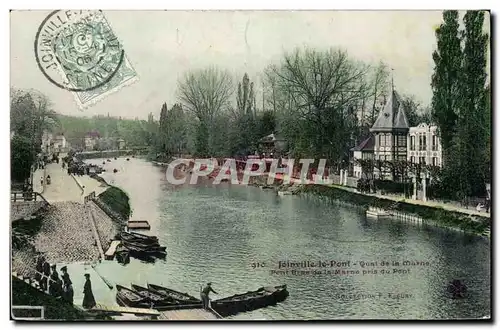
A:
10,10,492,119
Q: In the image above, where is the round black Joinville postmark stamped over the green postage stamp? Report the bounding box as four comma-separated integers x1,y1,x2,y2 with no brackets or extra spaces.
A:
35,10,125,92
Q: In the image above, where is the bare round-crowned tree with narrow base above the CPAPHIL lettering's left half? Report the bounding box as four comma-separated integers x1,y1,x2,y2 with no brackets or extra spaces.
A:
178,67,233,156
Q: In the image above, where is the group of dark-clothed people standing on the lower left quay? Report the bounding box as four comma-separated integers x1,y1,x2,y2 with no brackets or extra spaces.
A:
35,254,96,309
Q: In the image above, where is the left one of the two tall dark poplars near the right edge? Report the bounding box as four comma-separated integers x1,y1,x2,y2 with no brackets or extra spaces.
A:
431,10,462,164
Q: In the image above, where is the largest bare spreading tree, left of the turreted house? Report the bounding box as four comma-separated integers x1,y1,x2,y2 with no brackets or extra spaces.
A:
270,48,368,164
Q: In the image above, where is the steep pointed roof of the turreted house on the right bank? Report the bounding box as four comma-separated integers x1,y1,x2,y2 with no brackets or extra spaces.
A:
370,90,409,132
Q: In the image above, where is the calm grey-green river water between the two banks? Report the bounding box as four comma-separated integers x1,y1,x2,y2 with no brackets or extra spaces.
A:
81,158,490,320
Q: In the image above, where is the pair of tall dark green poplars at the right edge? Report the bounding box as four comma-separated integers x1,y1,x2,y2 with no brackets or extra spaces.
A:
432,10,491,200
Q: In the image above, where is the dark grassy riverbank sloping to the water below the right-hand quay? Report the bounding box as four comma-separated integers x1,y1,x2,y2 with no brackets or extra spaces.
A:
298,185,490,235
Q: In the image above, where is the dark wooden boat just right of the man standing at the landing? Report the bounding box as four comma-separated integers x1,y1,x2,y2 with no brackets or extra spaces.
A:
210,284,288,316
